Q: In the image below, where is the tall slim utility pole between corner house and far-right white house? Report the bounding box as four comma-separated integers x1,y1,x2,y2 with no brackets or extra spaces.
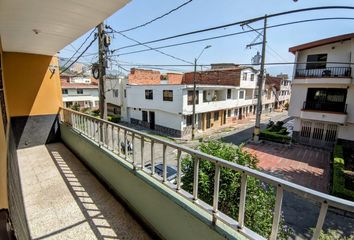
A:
253,15,267,142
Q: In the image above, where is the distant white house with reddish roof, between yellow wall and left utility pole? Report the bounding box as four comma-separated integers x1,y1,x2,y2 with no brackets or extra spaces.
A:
61,75,99,109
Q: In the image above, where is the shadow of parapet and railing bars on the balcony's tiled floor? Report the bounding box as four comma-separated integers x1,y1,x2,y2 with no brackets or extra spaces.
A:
41,143,150,240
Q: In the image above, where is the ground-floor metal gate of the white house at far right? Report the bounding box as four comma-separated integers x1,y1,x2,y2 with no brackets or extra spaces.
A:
300,121,338,148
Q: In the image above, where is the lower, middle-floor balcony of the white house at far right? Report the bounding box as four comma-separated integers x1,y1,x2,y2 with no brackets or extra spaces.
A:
300,101,347,124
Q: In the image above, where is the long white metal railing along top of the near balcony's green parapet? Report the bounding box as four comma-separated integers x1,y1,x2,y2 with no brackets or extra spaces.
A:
61,108,354,239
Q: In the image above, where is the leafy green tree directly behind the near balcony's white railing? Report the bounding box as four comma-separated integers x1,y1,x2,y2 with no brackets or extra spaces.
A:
182,141,291,239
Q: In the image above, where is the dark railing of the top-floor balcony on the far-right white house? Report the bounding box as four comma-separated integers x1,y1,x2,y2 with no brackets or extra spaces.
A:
295,67,351,78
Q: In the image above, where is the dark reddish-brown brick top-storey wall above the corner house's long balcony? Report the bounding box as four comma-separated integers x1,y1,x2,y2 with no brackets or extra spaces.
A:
182,69,241,86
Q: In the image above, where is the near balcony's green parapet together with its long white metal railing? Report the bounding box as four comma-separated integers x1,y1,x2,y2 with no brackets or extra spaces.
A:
54,109,354,239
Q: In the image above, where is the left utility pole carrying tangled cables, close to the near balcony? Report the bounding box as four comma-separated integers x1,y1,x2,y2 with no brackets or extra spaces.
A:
97,22,107,119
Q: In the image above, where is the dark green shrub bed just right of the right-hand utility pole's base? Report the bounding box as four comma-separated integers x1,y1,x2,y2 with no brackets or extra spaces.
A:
260,121,291,143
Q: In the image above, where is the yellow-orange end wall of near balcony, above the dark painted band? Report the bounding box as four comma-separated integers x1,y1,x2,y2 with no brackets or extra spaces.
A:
3,52,62,117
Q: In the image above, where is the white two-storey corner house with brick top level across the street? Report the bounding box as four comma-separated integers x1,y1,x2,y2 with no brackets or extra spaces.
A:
125,66,258,137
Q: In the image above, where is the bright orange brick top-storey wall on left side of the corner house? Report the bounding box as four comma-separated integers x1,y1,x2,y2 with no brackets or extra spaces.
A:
128,68,161,85
